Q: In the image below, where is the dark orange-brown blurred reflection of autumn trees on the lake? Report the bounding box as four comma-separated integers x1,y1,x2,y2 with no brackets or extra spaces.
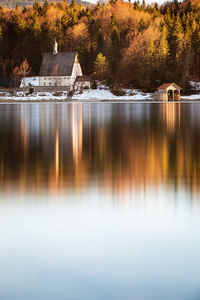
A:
0,103,200,192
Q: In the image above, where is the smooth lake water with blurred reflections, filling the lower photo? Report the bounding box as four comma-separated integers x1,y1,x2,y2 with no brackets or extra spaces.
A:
0,103,200,300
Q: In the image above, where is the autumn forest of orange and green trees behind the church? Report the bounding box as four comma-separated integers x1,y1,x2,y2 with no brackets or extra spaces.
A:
0,0,200,91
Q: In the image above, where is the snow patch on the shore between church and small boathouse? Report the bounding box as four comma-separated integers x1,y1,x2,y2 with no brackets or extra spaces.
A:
72,88,152,100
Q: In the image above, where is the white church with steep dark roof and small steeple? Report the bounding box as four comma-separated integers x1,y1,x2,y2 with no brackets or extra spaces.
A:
20,41,91,90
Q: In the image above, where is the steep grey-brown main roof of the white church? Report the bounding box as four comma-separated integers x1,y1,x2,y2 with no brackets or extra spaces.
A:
39,51,76,76
